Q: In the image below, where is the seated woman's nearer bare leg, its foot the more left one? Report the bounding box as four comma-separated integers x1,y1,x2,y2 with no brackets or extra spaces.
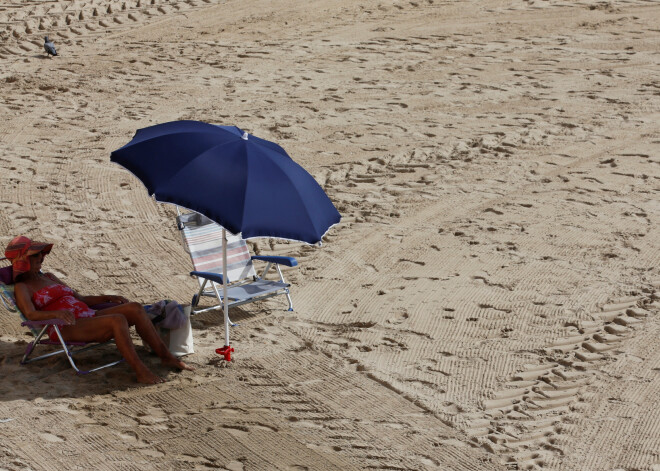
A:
61,314,164,384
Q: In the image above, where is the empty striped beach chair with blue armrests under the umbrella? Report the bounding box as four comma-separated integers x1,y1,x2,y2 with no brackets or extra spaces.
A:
177,212,298,325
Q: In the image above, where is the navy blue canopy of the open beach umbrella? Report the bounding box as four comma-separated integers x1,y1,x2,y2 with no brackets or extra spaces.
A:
110,121,341,244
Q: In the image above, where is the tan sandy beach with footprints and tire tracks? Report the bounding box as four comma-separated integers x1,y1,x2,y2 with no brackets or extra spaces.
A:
0,0,660,471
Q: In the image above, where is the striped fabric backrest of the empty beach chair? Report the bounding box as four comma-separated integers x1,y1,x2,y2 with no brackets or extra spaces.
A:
177,213,256,283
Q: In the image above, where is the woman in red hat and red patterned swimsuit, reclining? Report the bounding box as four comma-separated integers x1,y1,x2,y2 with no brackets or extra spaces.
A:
5,236,194,384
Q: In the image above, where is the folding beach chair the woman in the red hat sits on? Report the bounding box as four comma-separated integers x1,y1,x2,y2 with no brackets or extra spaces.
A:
0,258,124,375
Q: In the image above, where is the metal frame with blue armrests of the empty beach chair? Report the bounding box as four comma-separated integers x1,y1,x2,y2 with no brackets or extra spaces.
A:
177,210,298,326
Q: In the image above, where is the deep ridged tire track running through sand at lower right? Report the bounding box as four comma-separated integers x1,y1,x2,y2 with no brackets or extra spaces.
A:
464,287,660,469
